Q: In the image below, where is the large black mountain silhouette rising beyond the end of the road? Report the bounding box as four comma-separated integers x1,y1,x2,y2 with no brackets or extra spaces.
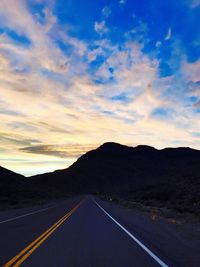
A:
0,142,200,214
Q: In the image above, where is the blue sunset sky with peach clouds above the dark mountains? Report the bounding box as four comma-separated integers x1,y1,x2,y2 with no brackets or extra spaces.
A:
0,0,200,176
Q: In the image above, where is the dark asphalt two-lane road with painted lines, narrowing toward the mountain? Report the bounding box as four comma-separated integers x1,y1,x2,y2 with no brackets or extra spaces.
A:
0,196,200,267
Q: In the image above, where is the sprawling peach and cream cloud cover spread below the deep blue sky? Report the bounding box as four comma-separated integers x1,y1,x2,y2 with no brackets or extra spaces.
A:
0,0,200,174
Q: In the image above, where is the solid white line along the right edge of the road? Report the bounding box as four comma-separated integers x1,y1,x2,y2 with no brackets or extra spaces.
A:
93,199,168,267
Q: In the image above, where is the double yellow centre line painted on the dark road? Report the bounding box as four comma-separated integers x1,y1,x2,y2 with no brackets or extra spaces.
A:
3,200,83,267
